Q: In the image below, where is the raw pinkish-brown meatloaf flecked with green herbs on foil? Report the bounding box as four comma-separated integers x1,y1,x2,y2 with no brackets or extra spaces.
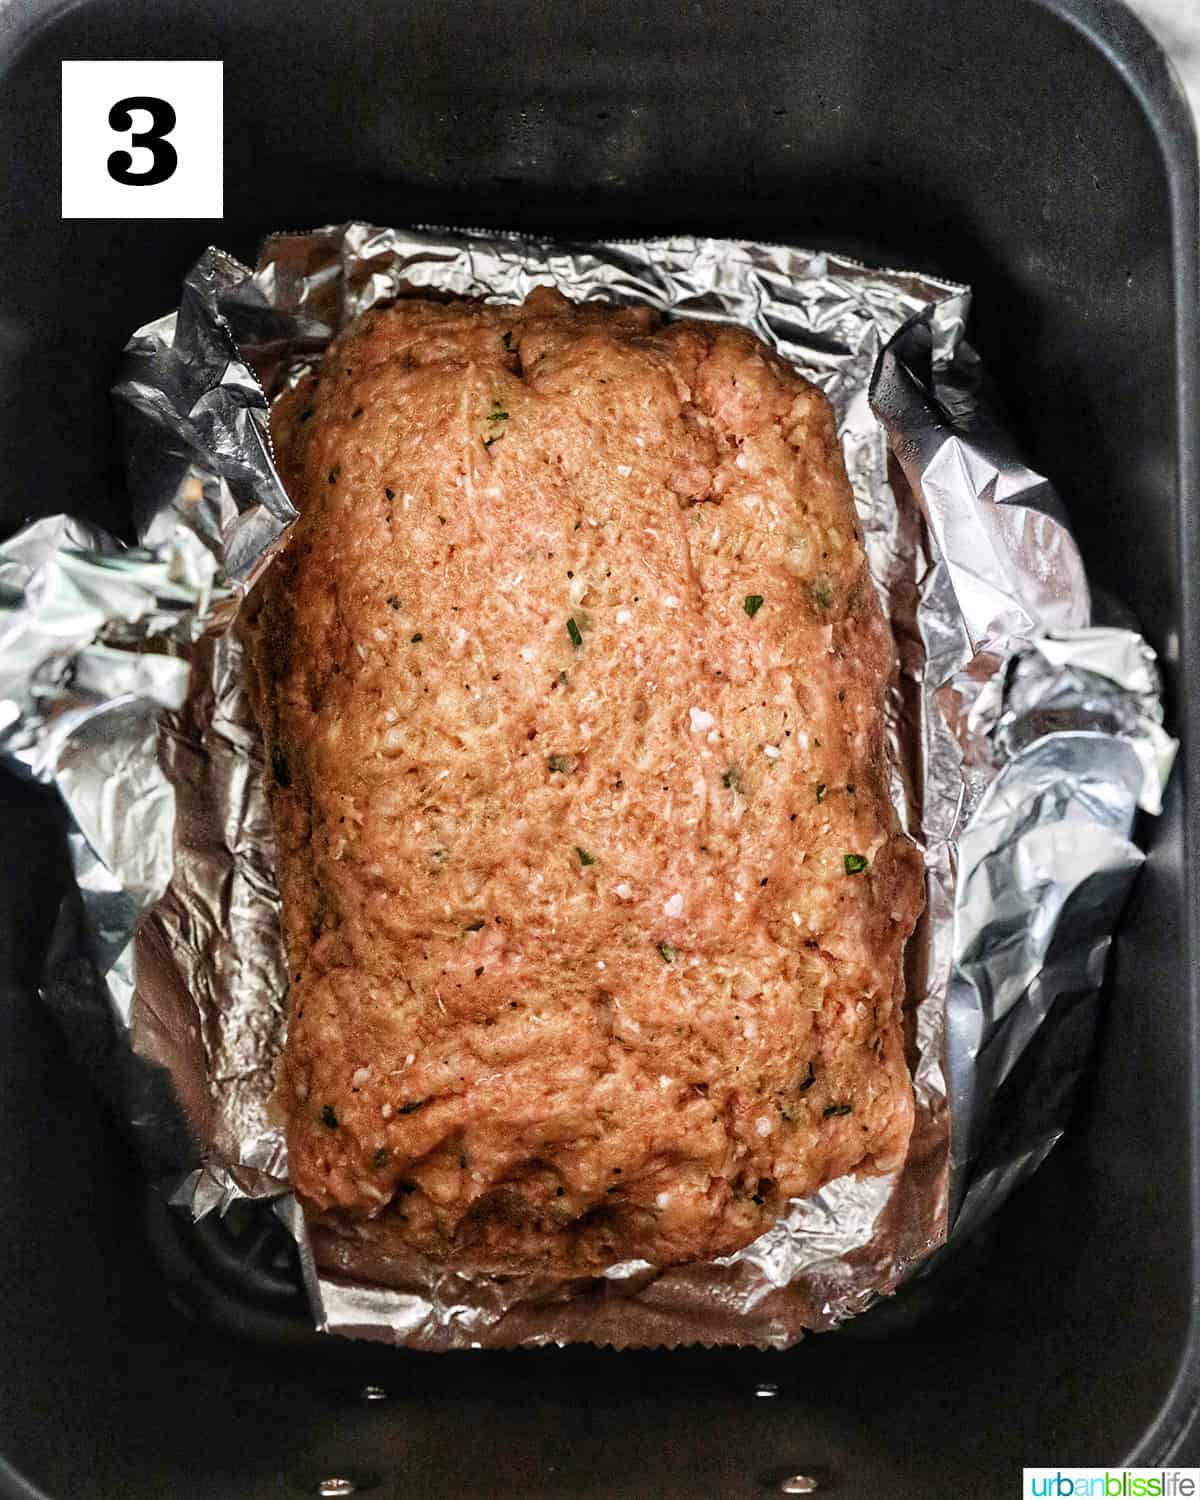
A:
241,290,921,1275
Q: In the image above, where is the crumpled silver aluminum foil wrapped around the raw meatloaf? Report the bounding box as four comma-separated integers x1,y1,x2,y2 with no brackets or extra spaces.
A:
0,224,1175,1349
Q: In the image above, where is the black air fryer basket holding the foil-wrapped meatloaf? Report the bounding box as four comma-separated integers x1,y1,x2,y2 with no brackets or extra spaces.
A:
0,0,1200,1500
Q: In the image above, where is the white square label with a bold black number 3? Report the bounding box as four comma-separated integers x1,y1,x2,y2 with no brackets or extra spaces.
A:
63,63,222,219
